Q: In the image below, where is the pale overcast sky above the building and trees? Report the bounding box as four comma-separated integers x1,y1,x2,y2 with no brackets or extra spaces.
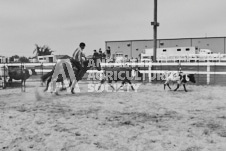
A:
0,0,226,57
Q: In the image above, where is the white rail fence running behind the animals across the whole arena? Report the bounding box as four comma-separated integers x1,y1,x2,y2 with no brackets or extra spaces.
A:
0,62,226,85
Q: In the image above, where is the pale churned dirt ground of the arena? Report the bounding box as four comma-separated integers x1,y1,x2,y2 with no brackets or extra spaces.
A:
0,83,226,151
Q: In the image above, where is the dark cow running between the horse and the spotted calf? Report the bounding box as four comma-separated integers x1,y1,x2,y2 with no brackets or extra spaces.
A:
98,67,142,91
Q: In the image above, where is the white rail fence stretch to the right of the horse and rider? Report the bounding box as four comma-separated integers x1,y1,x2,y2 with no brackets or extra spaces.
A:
98,62,226,85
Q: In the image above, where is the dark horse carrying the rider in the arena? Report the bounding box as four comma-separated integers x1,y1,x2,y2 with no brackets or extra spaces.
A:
41,58,101,95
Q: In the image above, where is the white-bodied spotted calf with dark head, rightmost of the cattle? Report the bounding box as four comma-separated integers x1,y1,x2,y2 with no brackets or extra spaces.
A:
164,71,196,92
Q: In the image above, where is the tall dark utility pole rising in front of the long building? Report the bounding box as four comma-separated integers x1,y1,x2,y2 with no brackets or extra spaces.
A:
151,0,159,62
